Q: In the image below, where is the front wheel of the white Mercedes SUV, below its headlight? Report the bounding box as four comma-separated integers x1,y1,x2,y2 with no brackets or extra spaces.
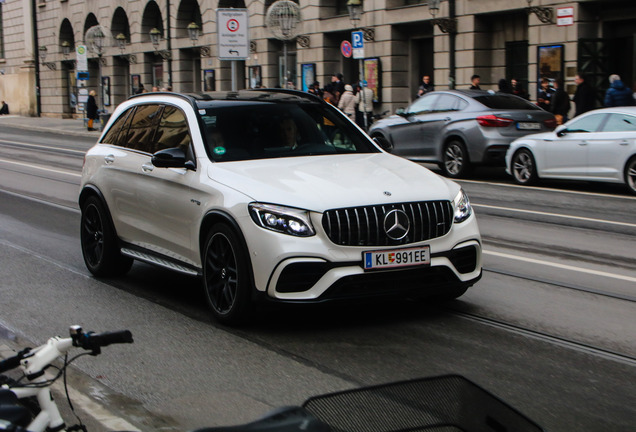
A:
203,223,252,325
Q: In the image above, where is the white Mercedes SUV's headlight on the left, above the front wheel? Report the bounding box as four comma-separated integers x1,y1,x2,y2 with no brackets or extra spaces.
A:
249,203,316,237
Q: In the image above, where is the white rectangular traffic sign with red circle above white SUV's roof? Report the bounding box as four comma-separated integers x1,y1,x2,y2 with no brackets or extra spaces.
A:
216,9,250,60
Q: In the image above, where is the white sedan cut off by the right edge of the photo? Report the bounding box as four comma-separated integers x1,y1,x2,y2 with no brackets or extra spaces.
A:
506,107,636,194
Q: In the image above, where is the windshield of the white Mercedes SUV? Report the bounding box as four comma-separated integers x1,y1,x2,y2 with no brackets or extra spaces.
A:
199,101,380,162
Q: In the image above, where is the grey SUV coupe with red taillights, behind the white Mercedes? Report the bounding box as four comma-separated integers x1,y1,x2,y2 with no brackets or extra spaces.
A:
369,90,557,178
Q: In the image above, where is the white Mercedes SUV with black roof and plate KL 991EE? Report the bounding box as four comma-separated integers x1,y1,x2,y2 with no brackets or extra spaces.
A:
79,90,482,323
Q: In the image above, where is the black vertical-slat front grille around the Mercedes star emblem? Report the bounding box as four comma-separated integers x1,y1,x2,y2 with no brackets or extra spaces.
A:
322,201,453,246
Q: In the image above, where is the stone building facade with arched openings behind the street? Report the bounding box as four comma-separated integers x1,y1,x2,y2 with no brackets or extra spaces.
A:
0,0,636,117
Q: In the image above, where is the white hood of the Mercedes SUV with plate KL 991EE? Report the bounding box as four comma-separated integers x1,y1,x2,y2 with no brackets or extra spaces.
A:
208,153,460,212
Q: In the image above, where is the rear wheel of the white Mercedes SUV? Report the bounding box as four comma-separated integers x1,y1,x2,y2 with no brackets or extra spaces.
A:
80,196,133,277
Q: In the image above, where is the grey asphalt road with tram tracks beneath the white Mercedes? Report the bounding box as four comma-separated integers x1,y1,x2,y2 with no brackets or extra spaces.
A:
0,127,636,431
